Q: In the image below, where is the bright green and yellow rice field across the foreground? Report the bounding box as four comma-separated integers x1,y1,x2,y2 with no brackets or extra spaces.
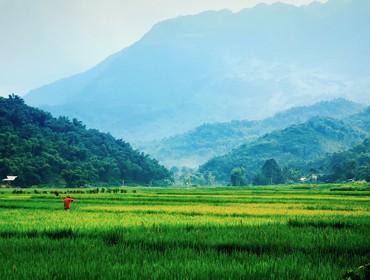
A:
0,185,370,279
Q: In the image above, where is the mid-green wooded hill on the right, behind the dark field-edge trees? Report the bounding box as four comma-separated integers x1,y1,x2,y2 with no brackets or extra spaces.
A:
200,108,370,182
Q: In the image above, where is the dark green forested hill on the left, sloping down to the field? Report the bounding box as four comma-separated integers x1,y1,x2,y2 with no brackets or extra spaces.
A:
0,95,170,186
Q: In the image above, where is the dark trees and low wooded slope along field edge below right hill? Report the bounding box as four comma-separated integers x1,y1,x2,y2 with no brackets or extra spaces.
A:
179,138,370,186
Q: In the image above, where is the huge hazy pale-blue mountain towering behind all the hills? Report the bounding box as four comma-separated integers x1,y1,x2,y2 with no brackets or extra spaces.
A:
25,0,370,142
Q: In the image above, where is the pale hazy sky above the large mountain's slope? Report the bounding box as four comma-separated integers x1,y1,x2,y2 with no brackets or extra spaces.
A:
0,0,324,96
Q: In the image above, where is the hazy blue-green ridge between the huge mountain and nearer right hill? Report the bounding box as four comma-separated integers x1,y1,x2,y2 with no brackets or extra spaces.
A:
139,99,364,168
